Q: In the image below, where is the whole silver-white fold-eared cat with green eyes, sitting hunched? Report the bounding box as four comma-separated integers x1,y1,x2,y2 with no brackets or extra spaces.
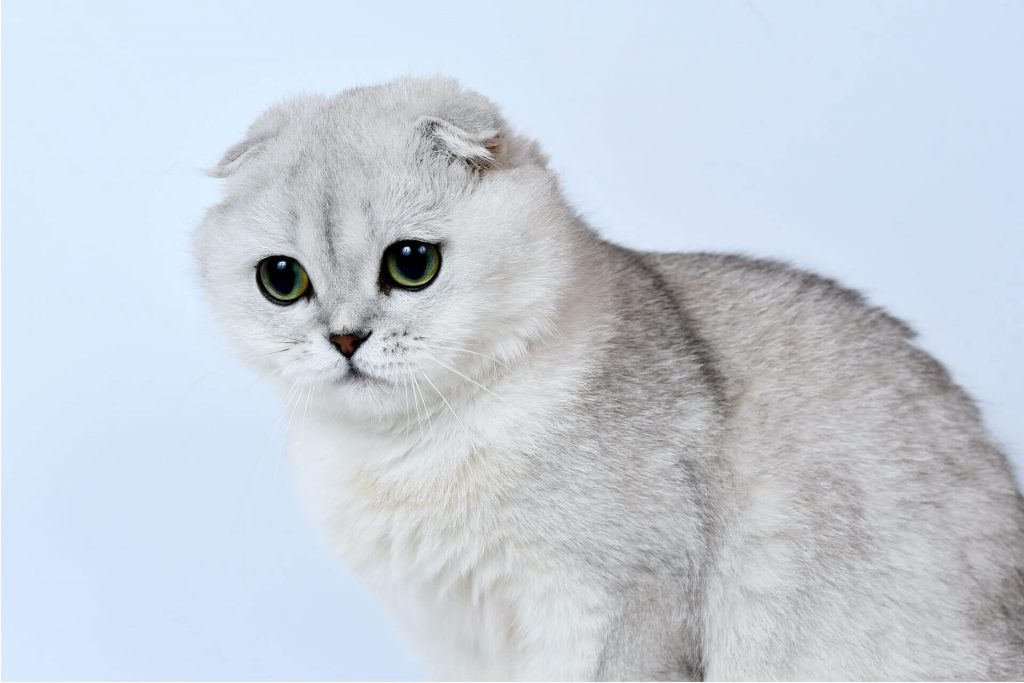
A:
196,80,1024,679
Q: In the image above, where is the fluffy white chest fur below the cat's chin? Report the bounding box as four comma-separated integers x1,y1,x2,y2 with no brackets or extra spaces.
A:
291,413,607,679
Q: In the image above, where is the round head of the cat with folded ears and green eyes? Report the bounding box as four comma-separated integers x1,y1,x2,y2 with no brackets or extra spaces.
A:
196,80,580,418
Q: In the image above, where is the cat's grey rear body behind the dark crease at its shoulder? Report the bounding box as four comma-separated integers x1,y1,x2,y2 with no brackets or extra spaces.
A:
645,249,1024,678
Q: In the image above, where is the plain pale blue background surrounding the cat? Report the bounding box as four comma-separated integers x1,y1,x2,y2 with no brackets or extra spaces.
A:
2,0,1024,680
